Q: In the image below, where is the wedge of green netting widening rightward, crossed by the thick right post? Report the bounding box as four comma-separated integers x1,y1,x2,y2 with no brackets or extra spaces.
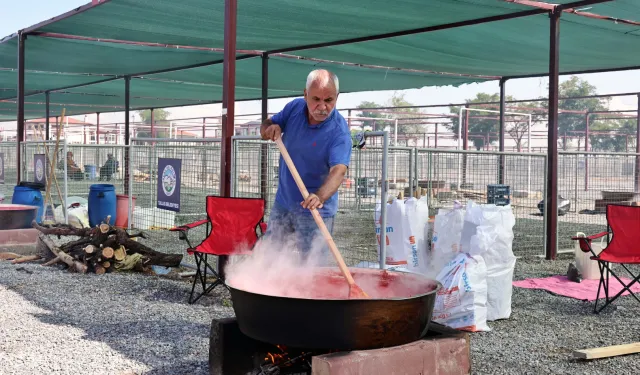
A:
297,14,640,76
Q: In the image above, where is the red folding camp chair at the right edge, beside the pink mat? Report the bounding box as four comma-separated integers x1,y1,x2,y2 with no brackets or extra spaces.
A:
572,204,640,313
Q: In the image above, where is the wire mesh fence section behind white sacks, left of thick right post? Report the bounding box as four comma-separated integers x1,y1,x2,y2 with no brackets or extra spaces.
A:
416,149,546,255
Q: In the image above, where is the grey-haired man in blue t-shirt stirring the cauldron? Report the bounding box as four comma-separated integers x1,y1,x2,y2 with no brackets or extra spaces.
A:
260,69,352,263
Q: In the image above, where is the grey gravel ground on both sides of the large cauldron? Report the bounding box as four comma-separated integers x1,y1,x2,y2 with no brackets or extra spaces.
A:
0,253,640,375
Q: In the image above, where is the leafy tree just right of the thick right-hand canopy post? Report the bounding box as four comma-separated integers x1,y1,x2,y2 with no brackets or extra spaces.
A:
542,76,611,150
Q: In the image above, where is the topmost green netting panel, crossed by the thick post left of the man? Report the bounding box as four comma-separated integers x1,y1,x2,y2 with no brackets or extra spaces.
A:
36,0,530,50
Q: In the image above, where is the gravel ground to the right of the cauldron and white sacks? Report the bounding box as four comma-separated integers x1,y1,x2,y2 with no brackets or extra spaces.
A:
471,254,640,375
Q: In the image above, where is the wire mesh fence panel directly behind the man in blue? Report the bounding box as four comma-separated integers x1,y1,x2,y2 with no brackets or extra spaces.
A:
232,137,390,266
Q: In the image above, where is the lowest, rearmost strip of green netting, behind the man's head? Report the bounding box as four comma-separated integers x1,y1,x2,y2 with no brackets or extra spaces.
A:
0,57,482,120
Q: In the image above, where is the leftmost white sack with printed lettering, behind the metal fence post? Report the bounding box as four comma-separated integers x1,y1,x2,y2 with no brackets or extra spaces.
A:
374,198,410,266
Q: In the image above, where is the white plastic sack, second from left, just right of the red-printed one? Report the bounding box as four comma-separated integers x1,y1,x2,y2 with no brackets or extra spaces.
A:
402,197,429,274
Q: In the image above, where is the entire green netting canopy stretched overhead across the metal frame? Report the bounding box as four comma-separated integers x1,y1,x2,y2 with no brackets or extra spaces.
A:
0,0,640,119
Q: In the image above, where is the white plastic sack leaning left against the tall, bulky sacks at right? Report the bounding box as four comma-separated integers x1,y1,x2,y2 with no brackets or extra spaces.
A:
429,202,465,273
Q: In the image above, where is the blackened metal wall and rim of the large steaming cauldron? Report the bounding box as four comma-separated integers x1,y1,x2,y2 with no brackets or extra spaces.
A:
228,269,442,350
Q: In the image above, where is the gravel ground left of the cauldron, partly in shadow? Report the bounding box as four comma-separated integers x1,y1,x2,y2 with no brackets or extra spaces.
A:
0,262,233,375
